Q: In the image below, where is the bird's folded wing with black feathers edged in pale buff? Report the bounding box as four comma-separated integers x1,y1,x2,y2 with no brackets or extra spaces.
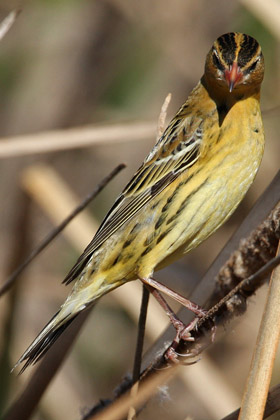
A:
63,114,202,284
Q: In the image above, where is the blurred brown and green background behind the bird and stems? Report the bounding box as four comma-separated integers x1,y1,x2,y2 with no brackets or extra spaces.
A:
0,0,280,420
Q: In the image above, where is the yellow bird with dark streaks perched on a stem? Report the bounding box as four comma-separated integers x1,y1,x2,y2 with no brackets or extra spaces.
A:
15,32,264,371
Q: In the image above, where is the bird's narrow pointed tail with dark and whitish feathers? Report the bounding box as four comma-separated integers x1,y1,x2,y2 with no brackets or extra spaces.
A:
12,311,79,374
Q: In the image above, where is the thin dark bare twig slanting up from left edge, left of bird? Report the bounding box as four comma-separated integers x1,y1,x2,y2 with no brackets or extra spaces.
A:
0,163,125,297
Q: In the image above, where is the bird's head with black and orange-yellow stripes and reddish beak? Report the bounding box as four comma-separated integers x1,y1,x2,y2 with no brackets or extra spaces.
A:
204,32,264,93
